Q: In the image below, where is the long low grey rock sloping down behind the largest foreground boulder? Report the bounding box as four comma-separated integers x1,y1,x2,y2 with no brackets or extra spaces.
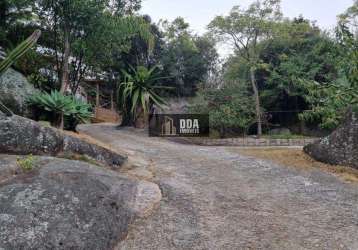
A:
0,113,127,168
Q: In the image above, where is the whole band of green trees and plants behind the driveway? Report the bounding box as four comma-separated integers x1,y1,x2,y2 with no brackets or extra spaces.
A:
0,0,358,137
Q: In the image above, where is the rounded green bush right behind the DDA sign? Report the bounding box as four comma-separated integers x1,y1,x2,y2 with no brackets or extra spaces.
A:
190,86,255,137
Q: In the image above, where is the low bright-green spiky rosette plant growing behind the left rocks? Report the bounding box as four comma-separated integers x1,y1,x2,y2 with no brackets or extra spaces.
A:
28,91,92,129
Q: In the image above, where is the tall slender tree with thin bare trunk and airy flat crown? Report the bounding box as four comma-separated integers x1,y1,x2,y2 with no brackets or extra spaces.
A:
209,0,282,136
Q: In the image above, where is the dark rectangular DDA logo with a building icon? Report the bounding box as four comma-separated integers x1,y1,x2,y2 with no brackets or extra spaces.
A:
149,114,209,137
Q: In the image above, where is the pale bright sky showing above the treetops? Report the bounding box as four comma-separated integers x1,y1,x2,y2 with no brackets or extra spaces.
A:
141,0,353,57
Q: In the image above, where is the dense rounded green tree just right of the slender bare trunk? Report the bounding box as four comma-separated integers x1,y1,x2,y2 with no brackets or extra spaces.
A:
257,17,342,127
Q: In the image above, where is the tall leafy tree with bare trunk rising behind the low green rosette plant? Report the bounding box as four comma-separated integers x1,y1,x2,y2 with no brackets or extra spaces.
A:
36,0,106,93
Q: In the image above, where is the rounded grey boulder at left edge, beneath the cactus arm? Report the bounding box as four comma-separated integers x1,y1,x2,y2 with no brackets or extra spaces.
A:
0,68,36,115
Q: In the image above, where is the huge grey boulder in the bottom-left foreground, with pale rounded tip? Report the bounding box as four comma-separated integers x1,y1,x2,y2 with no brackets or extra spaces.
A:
0,155,161,250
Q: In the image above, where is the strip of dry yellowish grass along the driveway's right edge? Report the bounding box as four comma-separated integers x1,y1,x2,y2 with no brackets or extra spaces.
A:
238,148,358,183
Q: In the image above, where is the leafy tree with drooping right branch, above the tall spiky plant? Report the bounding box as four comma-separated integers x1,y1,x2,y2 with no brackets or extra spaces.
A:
71,12,154,93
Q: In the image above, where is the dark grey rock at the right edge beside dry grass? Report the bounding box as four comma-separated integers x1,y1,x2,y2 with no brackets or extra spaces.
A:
304,111,358,169
